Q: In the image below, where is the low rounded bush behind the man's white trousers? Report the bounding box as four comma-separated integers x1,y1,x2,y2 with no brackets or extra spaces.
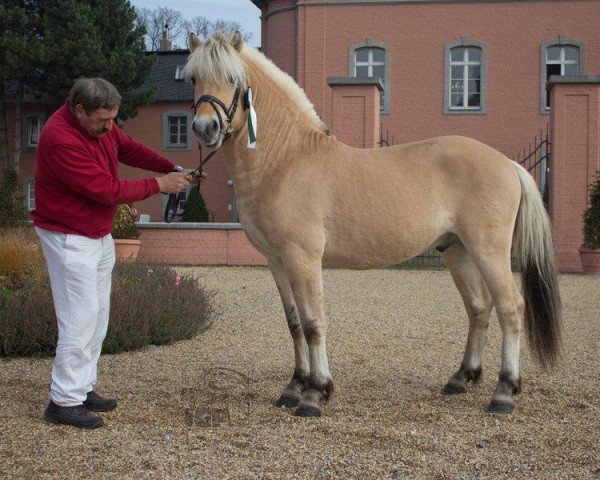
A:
0,255,213,356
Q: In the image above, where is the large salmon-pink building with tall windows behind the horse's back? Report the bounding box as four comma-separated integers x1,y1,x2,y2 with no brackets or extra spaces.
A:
253,0,600,157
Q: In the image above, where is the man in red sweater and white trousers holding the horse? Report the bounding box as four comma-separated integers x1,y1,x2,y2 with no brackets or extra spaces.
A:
31,78,200,428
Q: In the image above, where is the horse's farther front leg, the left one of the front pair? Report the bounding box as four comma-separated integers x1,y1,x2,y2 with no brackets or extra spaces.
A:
269,261,310,408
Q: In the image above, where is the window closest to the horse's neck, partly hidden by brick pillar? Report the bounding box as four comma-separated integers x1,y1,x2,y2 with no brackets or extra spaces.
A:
349,39,390,112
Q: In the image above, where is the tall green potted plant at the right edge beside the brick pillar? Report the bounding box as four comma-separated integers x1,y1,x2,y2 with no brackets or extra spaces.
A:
579,170,600,275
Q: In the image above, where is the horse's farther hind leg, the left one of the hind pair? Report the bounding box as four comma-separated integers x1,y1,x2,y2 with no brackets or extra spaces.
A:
442,242,493,395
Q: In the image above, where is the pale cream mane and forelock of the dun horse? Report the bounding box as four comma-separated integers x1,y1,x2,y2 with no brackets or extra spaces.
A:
184,33,328,131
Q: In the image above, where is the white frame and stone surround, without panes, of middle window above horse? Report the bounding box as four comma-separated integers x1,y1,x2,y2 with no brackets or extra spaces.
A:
444,37,487,115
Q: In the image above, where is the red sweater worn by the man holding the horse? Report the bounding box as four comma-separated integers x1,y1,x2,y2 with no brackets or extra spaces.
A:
31,103,175,238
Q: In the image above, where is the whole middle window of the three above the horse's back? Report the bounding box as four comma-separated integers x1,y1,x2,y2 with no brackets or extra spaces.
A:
444,38,486,113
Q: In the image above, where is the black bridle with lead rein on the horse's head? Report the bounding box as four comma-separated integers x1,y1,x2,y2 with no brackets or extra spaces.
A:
165,86,245,223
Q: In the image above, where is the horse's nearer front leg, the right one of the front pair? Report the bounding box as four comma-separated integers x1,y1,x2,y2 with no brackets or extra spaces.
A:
285,254,333,417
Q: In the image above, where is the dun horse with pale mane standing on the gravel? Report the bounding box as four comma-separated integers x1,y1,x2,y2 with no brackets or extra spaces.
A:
185,33,561,416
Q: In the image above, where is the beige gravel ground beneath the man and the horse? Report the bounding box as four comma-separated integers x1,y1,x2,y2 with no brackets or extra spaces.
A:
0,267,600,479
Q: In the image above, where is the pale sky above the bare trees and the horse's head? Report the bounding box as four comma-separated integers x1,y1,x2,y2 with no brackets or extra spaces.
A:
130,0,260,47
